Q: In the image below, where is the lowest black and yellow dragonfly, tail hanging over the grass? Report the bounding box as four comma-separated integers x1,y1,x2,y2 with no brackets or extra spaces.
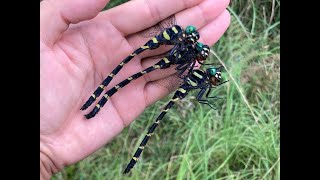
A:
124,66,227,174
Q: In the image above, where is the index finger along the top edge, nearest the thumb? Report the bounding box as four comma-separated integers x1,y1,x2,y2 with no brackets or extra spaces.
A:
99,0,203,35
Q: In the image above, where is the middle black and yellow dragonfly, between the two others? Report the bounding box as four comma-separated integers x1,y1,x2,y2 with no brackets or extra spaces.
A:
85,42,209,119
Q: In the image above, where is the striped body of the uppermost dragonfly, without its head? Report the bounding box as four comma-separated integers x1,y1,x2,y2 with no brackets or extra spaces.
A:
80,25,183,110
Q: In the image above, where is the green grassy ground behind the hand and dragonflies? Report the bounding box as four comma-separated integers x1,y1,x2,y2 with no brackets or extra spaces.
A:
53,0,280,180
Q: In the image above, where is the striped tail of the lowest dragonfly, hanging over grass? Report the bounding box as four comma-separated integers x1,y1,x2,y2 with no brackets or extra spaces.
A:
123,85,188,174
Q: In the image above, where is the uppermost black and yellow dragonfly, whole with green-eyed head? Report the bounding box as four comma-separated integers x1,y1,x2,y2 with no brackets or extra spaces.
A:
81,25,200,110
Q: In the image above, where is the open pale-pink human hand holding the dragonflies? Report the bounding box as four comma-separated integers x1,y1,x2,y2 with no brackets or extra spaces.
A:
40,0,230,179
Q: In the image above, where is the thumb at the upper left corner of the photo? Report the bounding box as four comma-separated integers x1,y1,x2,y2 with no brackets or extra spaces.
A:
40,0,109,47
